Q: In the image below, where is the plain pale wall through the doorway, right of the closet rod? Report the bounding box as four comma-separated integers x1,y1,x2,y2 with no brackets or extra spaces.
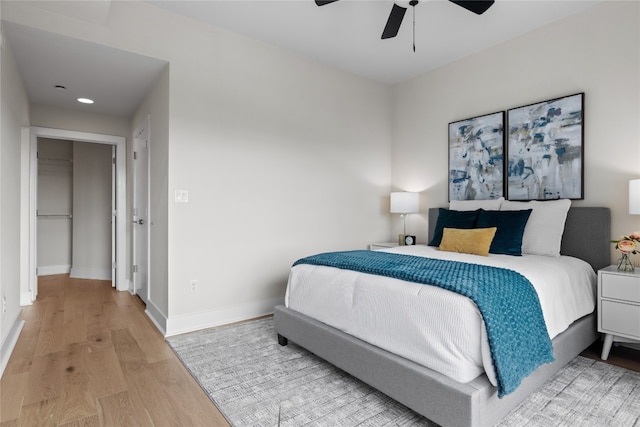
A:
71,141,112,280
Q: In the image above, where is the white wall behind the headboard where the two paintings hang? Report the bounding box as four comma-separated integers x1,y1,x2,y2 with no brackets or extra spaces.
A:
392,1,640,261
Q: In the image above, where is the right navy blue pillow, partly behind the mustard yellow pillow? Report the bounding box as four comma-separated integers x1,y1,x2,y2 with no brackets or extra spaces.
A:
476,209,532,255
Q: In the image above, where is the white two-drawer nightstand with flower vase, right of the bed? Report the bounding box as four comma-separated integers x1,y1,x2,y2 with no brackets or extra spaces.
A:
598,265,640,360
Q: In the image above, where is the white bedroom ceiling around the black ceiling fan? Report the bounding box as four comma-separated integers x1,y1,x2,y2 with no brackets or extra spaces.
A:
151,0,601,84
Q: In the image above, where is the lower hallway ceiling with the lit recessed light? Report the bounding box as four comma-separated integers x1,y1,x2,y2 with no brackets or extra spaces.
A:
2,22,167,116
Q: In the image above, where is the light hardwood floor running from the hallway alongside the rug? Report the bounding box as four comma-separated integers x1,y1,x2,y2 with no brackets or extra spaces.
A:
0,275,228,427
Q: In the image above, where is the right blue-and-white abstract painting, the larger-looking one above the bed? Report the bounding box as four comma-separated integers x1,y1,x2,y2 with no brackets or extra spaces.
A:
507,93,584,200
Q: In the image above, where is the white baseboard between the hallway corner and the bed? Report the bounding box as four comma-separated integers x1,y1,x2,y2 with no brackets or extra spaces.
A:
164,298,284,337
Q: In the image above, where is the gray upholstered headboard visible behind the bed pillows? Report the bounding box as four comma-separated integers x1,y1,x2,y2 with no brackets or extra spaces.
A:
428,207,611,271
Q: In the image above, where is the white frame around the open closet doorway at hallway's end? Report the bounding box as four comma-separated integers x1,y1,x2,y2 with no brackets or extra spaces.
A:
27,126,129,302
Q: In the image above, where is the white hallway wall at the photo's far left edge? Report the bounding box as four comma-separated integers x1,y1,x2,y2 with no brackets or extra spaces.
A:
0,20,29,375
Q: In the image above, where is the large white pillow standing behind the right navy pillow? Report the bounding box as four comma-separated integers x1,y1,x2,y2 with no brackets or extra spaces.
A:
500,199,571,256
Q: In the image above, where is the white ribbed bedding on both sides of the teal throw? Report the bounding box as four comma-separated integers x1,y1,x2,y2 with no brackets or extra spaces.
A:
285,245,596,385
